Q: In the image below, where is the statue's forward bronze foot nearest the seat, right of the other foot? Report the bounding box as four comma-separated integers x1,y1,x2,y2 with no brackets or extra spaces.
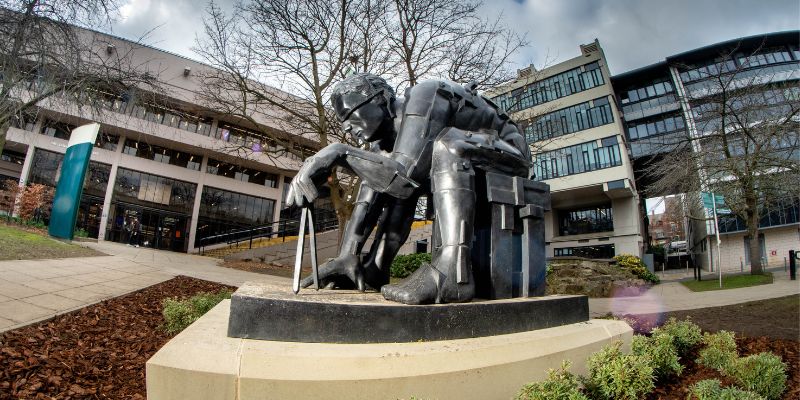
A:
381,246,475,304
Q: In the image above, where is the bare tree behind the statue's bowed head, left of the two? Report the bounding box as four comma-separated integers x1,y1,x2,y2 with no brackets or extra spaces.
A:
195,0,372,233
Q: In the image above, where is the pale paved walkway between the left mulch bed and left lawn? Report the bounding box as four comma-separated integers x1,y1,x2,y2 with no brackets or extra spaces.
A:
0,242,291,332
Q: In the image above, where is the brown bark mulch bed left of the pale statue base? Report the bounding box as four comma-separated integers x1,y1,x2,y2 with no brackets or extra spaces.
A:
0,276,235,399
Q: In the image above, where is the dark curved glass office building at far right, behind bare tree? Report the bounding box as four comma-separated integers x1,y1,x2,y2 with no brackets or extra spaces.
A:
611,31,800,270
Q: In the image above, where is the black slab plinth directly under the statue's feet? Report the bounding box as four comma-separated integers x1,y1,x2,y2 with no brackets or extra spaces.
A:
228,282,589,343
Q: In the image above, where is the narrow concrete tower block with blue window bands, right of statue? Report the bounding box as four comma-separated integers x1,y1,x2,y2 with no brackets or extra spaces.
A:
489,40,644,258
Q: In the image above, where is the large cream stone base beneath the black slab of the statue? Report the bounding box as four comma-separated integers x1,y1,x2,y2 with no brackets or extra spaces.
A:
147,300,633,400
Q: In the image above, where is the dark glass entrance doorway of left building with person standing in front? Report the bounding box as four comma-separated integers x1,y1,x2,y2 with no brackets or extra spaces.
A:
109,203,190,252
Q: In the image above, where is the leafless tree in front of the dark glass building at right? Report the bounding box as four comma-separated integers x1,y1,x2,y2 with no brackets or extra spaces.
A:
645,45,800,274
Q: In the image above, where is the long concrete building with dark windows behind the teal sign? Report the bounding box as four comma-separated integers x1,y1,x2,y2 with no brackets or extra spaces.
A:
0,28,317,252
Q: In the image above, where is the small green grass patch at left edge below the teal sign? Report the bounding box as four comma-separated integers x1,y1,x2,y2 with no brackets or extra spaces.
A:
0,224,105,260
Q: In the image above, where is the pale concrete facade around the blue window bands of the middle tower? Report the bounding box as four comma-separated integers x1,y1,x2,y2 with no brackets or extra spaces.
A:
488,41,643,258
